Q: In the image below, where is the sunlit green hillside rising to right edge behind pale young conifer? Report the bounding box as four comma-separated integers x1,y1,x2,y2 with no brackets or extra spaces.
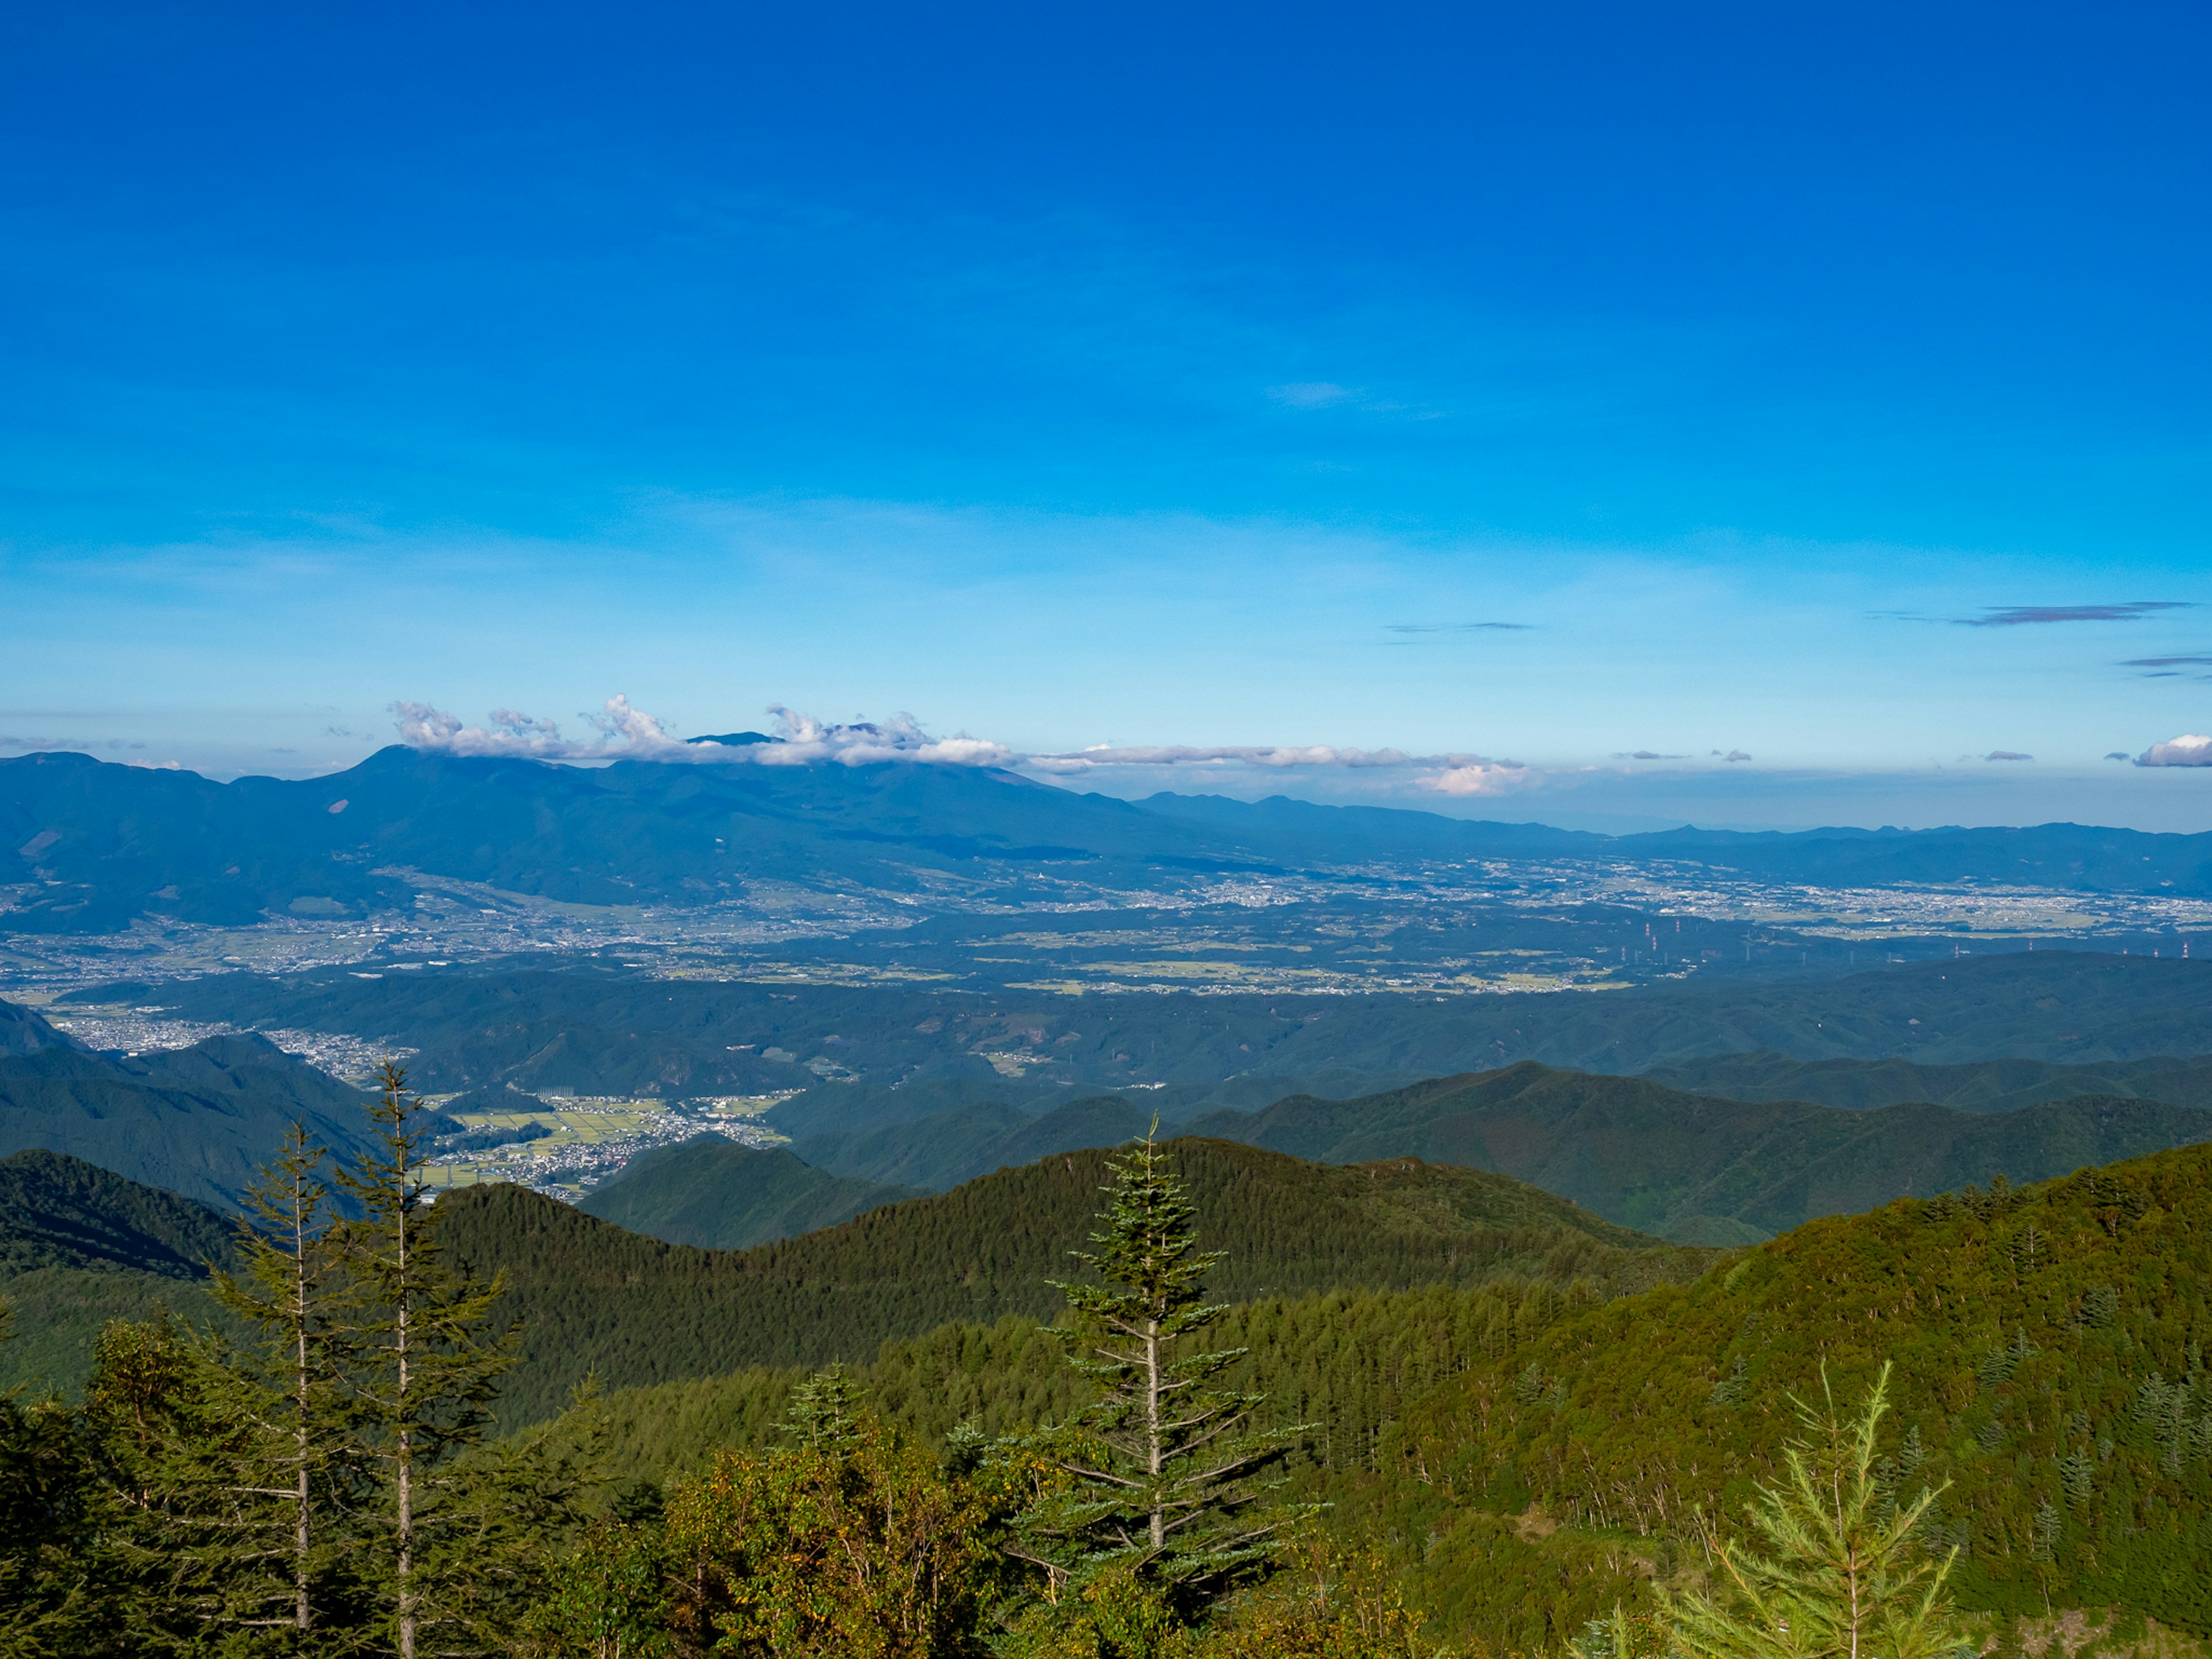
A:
1362,1146,2212,1639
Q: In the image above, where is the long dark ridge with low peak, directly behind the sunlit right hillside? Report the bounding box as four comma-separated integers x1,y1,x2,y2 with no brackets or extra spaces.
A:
1183,1062,2212,1243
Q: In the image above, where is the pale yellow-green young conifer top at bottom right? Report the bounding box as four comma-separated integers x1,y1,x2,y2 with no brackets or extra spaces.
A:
1664,1365,1960,1659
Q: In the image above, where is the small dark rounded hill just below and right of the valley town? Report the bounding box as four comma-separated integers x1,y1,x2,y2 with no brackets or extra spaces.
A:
577,1135,920,1250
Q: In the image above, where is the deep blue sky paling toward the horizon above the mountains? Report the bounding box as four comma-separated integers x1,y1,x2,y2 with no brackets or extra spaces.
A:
0,5,2212,830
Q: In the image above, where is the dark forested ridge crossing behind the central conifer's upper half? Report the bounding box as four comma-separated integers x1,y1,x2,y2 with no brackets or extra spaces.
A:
438,1141,1703,1422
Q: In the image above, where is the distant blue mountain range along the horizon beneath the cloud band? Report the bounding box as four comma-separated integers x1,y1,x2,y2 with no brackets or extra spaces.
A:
13,745,2212,933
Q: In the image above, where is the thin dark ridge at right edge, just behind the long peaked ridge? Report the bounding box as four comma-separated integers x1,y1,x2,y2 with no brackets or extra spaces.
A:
1643,1048,2212,1113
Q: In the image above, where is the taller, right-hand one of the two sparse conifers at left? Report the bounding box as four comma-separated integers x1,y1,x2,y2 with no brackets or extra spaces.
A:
334,1064,516,1659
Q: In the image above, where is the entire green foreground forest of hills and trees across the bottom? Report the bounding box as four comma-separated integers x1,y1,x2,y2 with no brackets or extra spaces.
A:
0,1073,2212,1659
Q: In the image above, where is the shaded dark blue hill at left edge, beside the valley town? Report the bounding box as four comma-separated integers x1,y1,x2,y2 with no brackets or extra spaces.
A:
0,1035,380,1210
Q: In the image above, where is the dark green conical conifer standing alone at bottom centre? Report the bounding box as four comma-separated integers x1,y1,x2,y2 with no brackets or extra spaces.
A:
1016,1135,1305,1617
